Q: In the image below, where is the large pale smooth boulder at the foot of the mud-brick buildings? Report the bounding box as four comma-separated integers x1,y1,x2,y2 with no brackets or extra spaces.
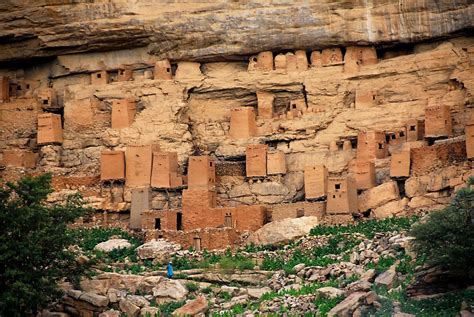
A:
246,217,319,245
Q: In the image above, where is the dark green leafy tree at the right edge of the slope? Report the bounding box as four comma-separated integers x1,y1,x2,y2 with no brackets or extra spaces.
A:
411,177,474,278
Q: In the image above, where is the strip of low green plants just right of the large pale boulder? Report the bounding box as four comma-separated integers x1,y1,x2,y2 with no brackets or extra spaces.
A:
310,216,418,239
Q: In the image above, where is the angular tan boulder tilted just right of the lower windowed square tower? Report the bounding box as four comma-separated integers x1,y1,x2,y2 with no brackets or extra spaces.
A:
359,181,399,212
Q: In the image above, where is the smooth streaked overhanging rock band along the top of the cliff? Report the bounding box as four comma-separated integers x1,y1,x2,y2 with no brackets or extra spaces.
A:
0,0,474,61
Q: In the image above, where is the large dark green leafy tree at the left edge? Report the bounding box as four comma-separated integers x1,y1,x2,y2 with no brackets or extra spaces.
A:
0,174,88,316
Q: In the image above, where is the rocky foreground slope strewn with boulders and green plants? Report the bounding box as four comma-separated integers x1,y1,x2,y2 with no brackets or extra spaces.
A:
44,215,474,317
